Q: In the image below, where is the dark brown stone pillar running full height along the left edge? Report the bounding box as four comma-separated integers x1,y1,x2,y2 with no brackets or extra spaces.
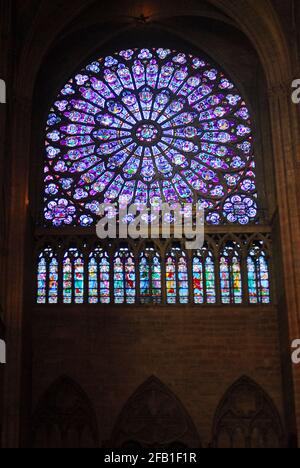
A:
0,0,32,440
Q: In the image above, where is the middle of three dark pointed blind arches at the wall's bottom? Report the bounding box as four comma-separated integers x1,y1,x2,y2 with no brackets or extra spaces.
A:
110,377,201,448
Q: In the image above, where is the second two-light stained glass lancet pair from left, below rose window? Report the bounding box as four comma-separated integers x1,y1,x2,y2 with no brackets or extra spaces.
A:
63,248,84,304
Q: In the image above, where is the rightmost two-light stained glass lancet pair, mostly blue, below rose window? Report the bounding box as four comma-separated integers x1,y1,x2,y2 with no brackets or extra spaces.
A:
247,242,270,304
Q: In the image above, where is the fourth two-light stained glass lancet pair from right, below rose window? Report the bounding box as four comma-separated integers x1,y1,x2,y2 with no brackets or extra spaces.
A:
166,247,189,304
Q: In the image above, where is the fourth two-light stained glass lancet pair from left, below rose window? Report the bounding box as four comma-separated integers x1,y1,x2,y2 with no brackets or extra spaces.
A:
114,247,136,304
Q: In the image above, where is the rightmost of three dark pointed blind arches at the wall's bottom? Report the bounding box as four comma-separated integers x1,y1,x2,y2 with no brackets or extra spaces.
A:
213,377,283,448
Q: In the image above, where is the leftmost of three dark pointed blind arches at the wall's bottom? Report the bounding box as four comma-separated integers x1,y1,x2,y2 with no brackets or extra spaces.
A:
32,376,98,448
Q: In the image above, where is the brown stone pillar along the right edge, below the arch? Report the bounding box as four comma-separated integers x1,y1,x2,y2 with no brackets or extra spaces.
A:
269,82,300,443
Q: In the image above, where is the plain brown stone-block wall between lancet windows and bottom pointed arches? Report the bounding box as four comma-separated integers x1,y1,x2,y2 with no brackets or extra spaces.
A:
32,306,284,446
